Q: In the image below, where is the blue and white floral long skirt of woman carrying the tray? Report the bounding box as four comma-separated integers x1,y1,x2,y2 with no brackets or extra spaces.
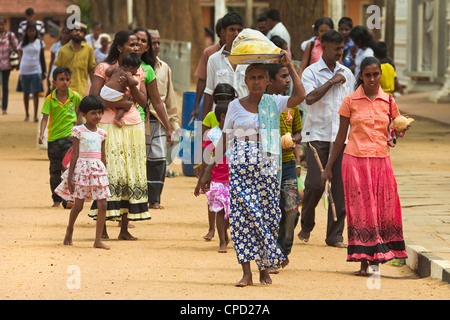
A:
229,140,285,270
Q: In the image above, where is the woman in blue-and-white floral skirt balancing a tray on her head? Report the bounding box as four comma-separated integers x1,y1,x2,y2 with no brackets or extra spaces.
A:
212,50,305,287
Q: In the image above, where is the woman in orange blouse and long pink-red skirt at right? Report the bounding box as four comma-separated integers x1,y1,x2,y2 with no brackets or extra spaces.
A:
322,57,407,275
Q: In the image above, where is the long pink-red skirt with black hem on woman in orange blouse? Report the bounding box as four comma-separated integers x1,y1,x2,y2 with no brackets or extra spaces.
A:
342,154,407,263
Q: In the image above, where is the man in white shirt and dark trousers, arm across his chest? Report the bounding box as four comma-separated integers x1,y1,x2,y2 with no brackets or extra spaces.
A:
298,30,355,248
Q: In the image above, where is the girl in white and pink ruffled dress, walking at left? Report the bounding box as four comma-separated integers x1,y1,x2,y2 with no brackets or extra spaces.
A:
55,96,111,249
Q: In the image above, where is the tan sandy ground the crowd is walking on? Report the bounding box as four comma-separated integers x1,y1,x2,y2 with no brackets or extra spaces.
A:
0,70,450,300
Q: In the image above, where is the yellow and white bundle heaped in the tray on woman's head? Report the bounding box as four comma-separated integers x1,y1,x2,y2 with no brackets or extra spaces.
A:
231,28,281,55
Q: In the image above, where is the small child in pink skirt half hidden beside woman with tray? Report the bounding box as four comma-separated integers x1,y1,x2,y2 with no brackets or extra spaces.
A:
194,101,230,253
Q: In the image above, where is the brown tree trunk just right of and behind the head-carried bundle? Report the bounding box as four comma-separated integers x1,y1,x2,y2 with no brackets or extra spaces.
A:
269,0,324,60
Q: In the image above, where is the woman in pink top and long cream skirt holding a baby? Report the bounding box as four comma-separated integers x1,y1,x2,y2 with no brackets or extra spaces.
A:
89,31,150,240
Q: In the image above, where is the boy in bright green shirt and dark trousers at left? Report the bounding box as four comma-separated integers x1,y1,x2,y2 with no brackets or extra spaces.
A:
39,67,81,207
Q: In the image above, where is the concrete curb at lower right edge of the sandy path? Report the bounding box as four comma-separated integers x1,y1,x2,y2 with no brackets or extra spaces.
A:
406,245,450,283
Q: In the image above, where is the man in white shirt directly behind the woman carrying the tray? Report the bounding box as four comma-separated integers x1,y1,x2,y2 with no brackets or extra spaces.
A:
202,12,248,120
